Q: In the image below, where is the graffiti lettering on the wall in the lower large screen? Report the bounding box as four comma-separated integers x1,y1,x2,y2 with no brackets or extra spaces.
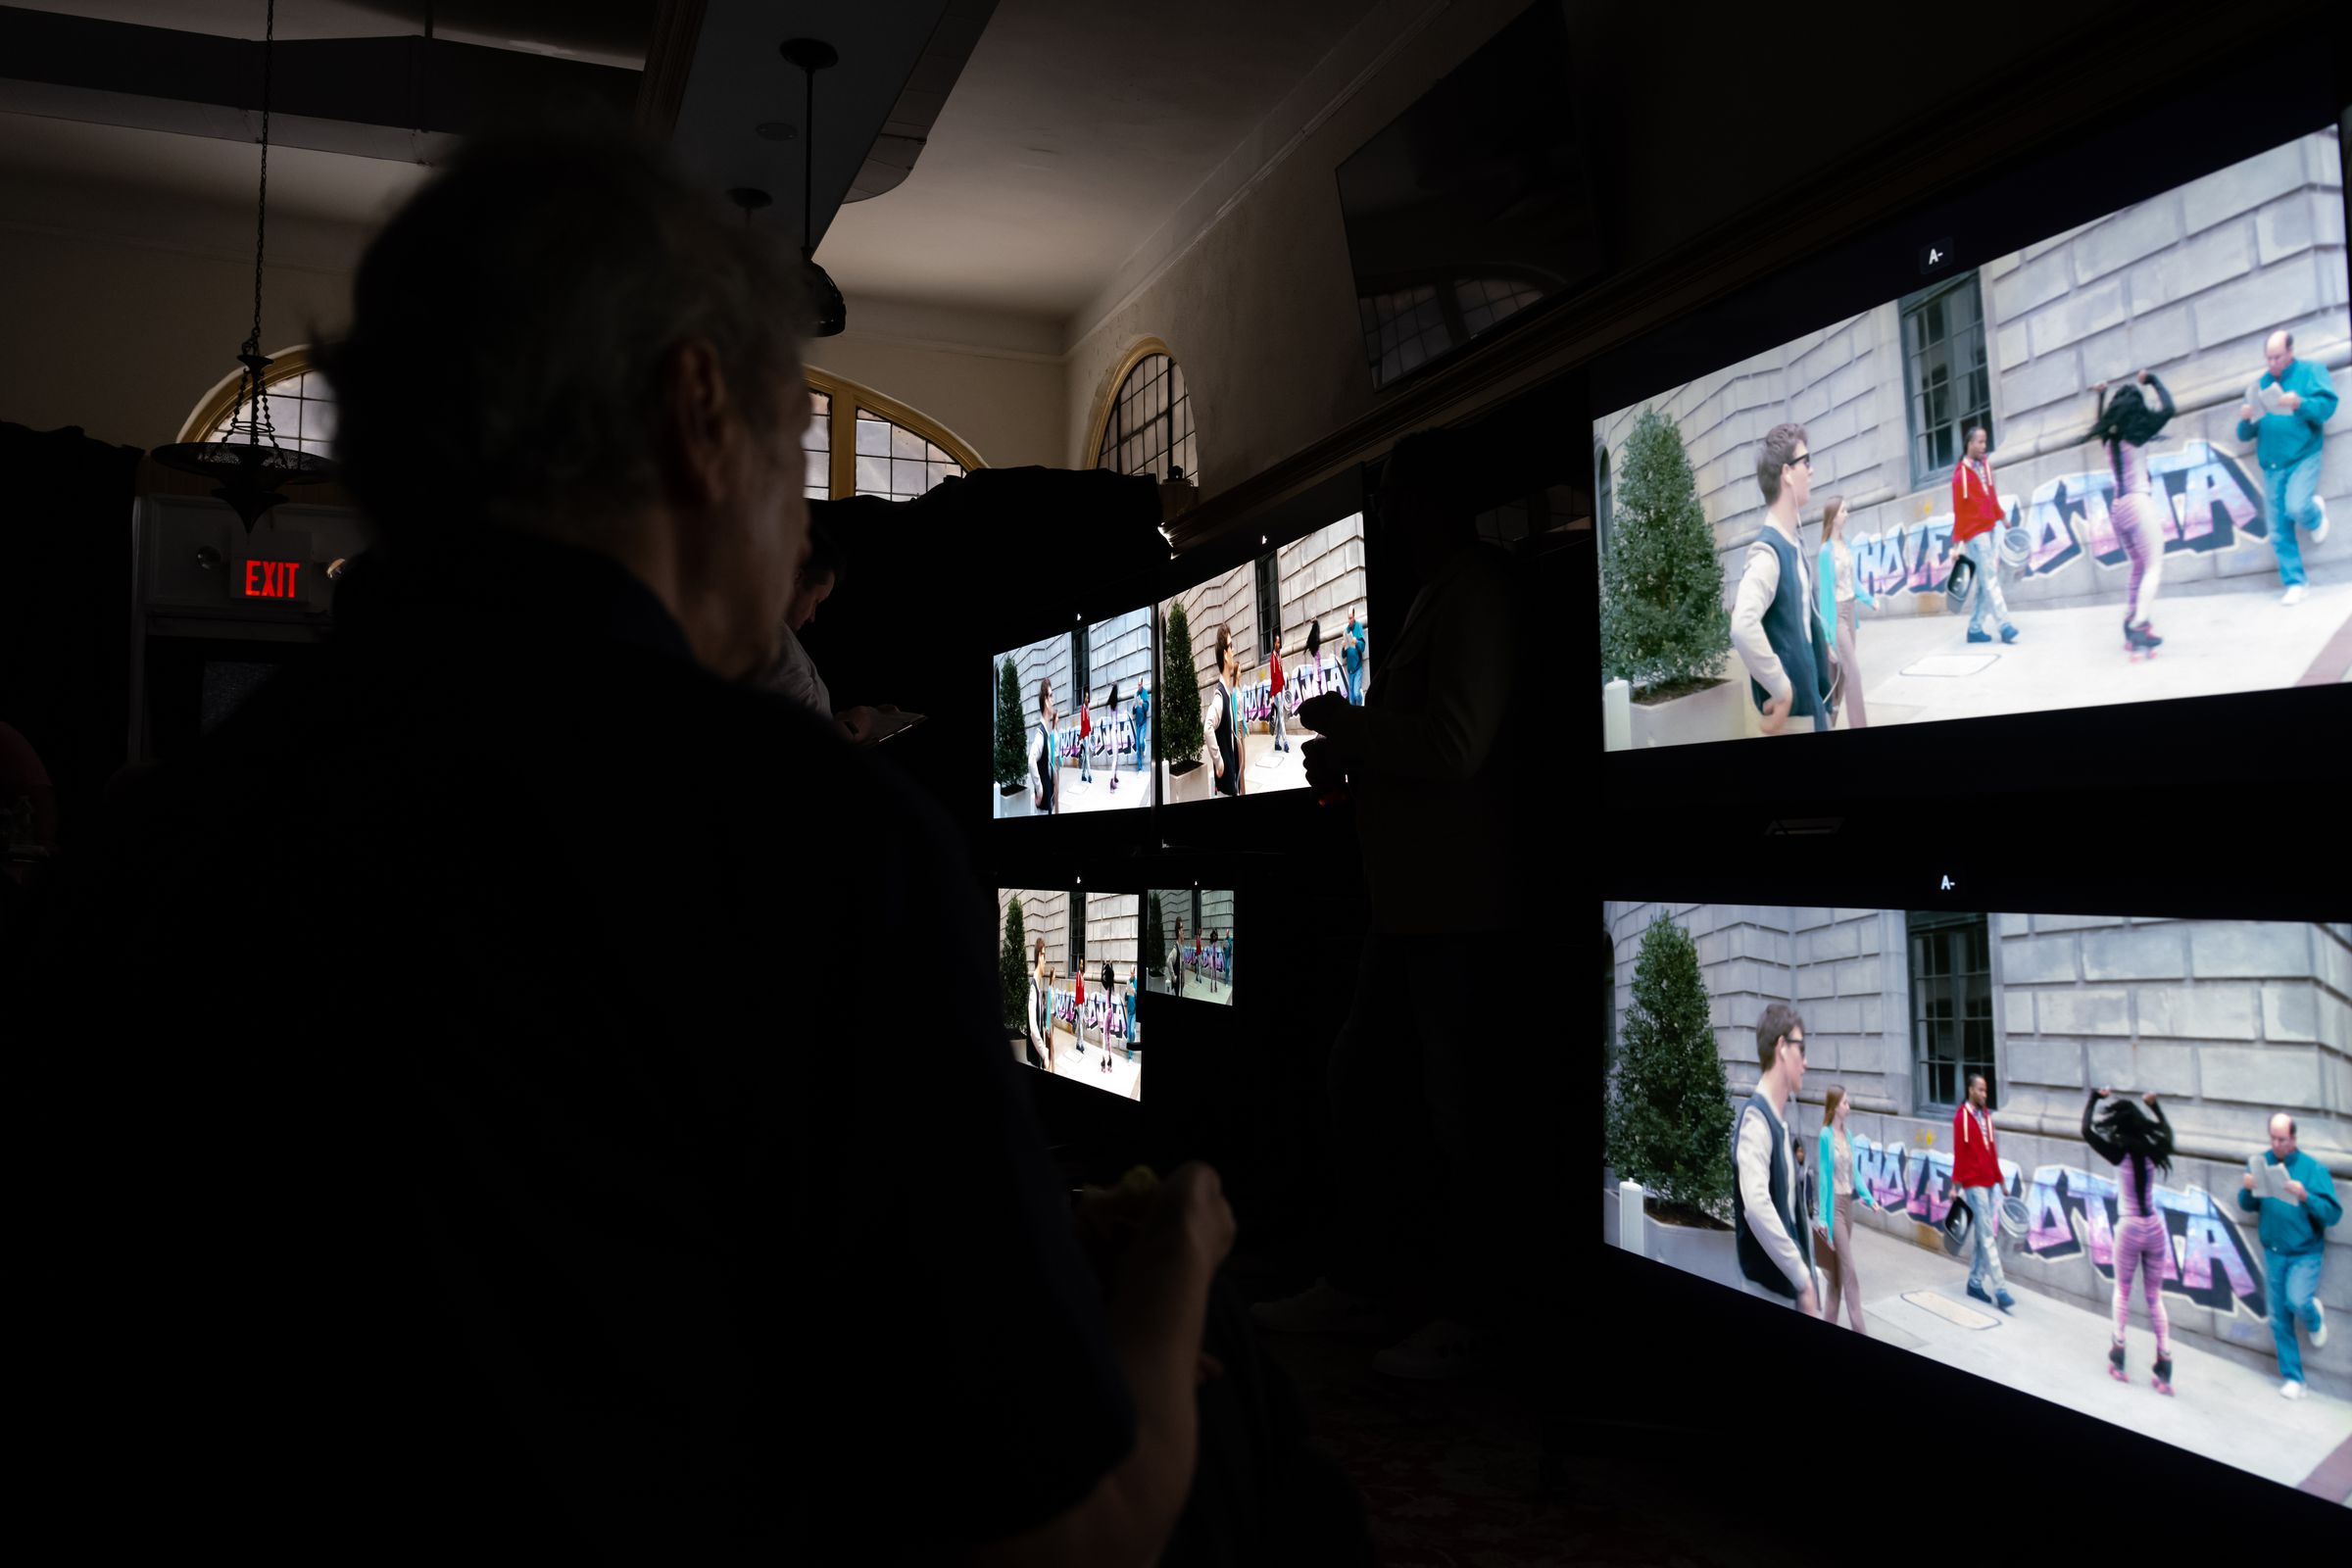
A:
1853,1138,2270,1319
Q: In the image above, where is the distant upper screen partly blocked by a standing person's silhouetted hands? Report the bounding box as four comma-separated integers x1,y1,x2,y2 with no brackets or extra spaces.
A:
1152,513,1371,804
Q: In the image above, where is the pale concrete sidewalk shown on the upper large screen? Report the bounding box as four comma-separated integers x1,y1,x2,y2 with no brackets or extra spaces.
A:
1839,583,2352,729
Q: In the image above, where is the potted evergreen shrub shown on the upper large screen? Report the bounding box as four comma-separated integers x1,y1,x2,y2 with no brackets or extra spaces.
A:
1601,409,1747,745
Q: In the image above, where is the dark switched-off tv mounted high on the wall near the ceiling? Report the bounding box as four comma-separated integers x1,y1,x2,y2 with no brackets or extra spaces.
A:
1339,0,1606,388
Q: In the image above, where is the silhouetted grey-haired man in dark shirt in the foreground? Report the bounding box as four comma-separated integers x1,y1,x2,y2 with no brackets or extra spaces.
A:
47,125,1233,1563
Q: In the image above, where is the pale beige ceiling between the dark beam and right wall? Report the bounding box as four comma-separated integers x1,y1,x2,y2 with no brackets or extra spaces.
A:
816,0,1376,319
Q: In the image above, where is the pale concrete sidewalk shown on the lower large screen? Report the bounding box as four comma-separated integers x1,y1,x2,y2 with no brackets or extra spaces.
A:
1823,1225,2352,1502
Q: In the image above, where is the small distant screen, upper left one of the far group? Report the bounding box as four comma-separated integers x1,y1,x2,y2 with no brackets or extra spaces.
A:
995,607,1152,820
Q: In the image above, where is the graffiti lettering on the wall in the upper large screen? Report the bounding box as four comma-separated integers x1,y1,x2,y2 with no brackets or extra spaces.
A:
1853,442,2270,595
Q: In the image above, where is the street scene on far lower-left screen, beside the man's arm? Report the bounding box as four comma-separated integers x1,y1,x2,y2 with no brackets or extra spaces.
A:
998,889,1143,1101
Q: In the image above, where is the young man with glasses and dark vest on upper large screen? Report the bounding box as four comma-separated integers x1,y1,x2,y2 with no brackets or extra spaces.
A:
1731,425,1835,736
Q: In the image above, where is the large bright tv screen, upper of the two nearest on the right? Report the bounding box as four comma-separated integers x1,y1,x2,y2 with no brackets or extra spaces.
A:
1592,127,2352,748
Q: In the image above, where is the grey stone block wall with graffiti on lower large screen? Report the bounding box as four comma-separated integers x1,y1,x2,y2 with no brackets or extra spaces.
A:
1604,903,2352,1396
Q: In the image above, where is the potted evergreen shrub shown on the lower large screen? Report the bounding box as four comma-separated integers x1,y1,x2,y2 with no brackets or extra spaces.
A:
1606,914,1739,1284
